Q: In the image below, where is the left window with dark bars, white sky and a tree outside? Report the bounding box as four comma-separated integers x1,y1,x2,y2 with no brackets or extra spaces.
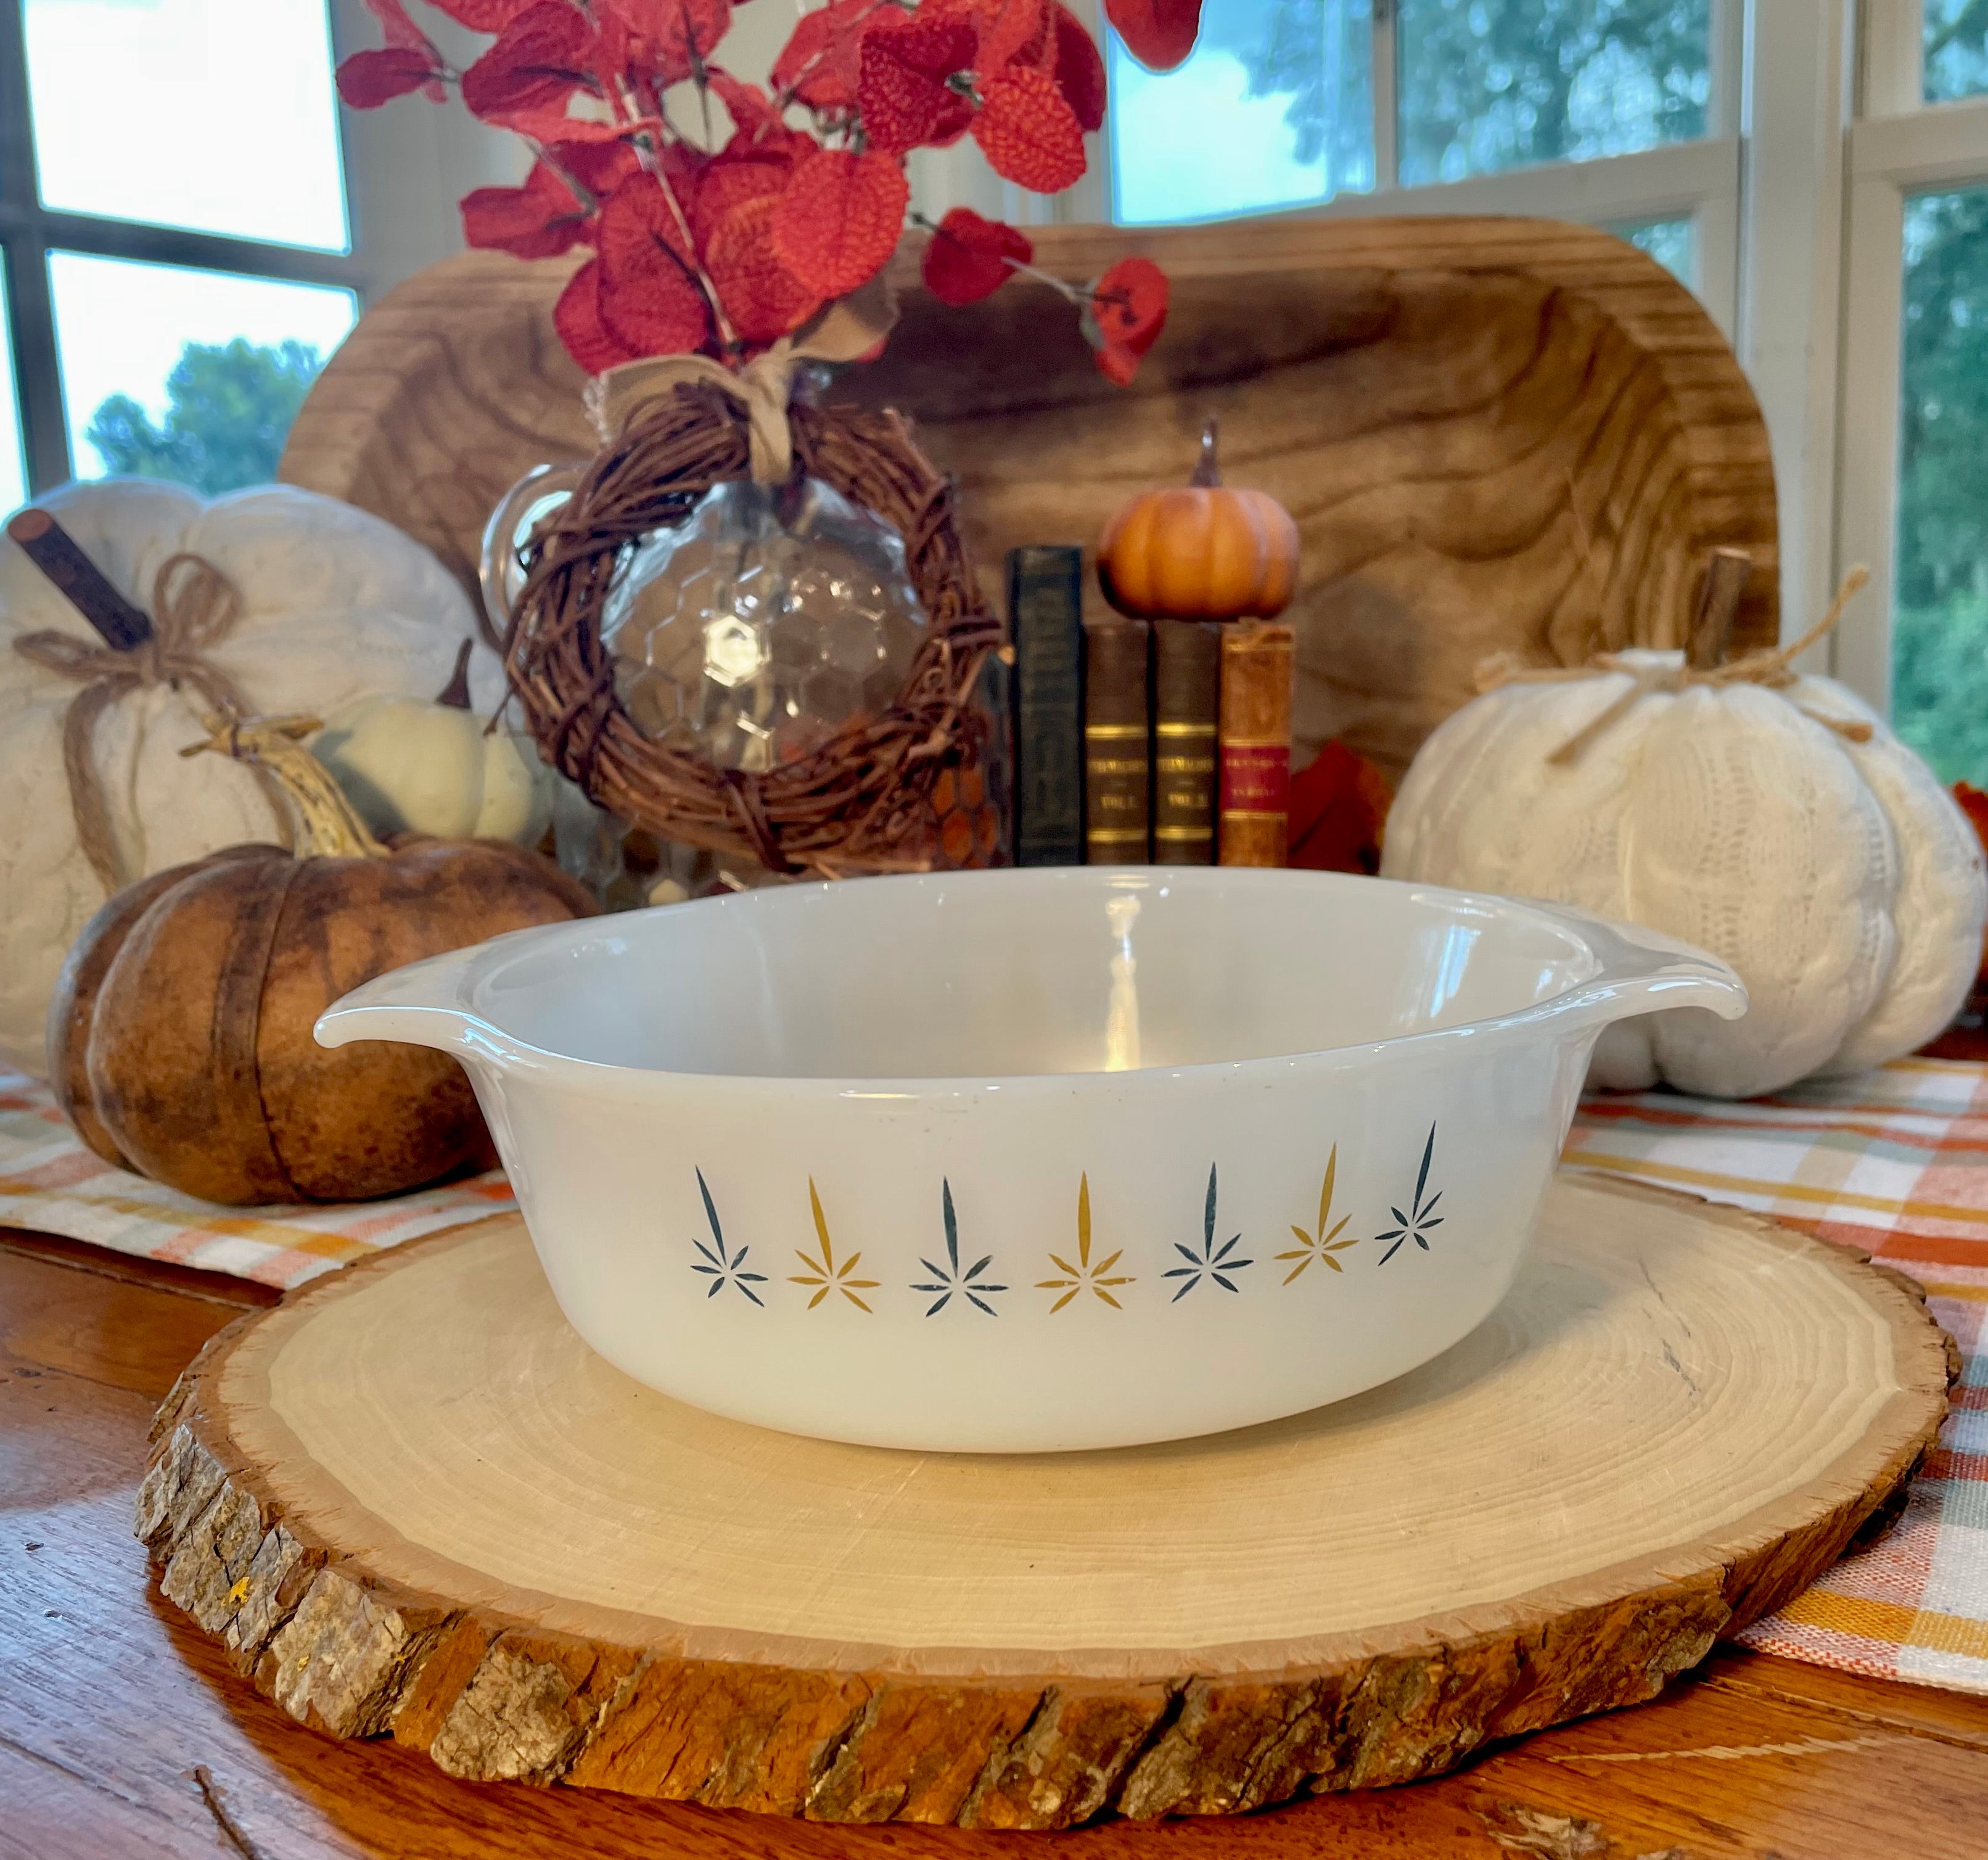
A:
0,0,366,497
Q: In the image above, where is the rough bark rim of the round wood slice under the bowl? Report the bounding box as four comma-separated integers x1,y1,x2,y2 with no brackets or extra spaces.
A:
137,1175,1954,1828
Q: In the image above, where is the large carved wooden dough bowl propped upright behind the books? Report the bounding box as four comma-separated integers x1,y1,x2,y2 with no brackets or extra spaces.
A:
281,217,1773,776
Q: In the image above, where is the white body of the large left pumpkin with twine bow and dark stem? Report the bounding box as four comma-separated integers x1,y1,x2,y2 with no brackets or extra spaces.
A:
0,479,503,1072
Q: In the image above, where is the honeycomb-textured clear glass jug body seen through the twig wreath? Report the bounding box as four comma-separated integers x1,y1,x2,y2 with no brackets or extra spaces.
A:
601,477,924,774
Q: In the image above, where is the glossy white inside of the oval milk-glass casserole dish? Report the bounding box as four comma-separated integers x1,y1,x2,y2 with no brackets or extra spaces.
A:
471,867,1598,1078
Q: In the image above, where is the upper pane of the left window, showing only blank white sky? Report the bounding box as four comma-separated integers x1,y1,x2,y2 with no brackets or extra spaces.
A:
26,0,346,250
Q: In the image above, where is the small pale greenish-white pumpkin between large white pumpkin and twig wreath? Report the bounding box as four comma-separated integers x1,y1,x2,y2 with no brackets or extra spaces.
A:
310,641,554,846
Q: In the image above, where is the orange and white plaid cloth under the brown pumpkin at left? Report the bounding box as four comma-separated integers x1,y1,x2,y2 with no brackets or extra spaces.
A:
0,1068,513,1291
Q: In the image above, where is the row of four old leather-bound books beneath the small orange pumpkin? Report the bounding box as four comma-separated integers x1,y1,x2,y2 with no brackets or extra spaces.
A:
1008,547,1292,865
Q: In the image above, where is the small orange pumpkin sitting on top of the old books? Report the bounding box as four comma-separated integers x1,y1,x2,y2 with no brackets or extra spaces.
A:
1098,420,1298,620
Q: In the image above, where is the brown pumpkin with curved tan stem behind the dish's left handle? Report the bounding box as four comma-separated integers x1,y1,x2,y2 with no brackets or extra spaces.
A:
47,716,594,1208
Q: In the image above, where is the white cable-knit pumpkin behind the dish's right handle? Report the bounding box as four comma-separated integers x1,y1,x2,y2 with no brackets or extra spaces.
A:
1382,652,1988,1098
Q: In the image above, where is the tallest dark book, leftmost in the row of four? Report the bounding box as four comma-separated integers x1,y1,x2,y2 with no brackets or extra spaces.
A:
1008,547,1083,865
